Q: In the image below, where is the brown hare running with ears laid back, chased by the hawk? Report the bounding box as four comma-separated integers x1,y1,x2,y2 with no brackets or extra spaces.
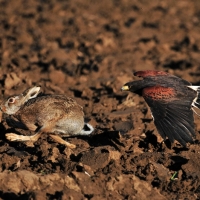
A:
0,86,94,148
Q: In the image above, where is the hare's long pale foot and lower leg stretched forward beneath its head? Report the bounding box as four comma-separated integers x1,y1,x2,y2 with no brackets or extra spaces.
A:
6,132,42,142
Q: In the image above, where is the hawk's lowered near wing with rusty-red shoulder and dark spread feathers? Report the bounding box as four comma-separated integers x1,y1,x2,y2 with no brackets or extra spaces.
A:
143,86,195,146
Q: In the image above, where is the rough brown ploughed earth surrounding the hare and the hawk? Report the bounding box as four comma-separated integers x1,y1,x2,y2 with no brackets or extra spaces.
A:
0,0,200,200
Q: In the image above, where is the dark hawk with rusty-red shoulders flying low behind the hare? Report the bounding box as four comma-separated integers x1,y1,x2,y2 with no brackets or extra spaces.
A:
122,70,200,146
